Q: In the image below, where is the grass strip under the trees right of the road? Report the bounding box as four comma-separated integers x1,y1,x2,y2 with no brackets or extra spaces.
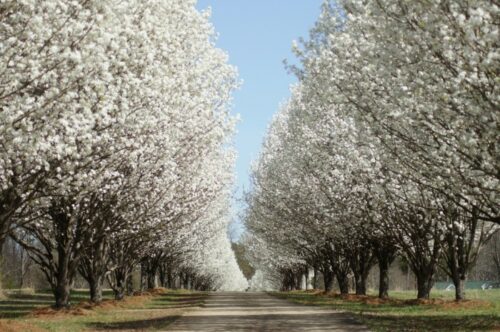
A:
271,289,500,331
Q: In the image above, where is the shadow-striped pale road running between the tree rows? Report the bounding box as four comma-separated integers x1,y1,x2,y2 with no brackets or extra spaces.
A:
168,293,368,332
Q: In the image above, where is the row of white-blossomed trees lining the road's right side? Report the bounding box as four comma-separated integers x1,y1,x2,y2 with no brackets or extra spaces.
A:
245,0,500,300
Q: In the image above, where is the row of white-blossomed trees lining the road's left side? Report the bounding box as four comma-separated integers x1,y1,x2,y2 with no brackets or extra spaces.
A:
0,0,246,307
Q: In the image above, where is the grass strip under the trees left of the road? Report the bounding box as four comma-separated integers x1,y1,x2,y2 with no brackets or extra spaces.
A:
0,290,206,332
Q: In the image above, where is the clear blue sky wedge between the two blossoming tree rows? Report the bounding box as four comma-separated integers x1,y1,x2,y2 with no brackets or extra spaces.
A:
197,0,322,236
